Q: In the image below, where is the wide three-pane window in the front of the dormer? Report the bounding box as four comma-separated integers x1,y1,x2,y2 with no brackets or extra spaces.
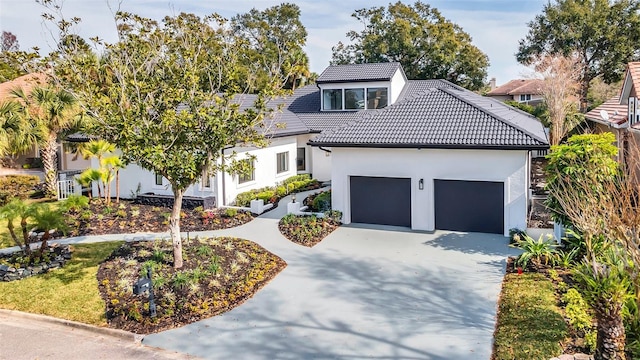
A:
322,87,389,110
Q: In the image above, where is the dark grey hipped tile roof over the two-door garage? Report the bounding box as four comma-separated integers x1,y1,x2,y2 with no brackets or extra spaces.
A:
310,87,548,149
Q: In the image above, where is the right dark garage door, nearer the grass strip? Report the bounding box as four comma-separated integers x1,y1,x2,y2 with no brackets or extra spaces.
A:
434,180,504,234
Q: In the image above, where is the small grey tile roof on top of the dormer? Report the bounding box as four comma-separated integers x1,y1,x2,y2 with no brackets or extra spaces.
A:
316,62,402,84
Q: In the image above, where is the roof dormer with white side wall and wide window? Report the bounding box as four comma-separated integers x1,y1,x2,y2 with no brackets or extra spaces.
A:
317,62,407,111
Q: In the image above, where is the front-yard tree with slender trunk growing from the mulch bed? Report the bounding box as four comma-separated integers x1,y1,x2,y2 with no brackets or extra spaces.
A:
56,13,283,268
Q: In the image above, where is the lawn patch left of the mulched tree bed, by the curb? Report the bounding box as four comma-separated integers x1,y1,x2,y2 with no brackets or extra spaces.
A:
0,241,123,326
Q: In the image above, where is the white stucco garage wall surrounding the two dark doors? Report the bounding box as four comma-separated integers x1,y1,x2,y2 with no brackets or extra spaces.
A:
331,148,529,236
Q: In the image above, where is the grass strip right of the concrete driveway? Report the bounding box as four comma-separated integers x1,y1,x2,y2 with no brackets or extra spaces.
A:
493,273,569,360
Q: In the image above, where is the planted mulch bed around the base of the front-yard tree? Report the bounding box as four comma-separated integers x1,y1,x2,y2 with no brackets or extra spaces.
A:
97,237,286,334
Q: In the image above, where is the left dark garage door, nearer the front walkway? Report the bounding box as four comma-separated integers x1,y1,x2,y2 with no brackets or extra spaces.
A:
350,176,411,227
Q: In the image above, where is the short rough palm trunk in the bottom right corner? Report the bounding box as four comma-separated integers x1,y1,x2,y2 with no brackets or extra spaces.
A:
595,299,626,360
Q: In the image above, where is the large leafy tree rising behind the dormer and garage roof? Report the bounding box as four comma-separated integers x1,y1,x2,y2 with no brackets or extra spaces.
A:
331,1,489,90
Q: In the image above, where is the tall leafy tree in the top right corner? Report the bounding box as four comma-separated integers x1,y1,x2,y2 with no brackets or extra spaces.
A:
516,0,640,111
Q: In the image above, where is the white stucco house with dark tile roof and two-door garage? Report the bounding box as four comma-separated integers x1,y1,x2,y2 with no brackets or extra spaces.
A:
107,63,548,235
